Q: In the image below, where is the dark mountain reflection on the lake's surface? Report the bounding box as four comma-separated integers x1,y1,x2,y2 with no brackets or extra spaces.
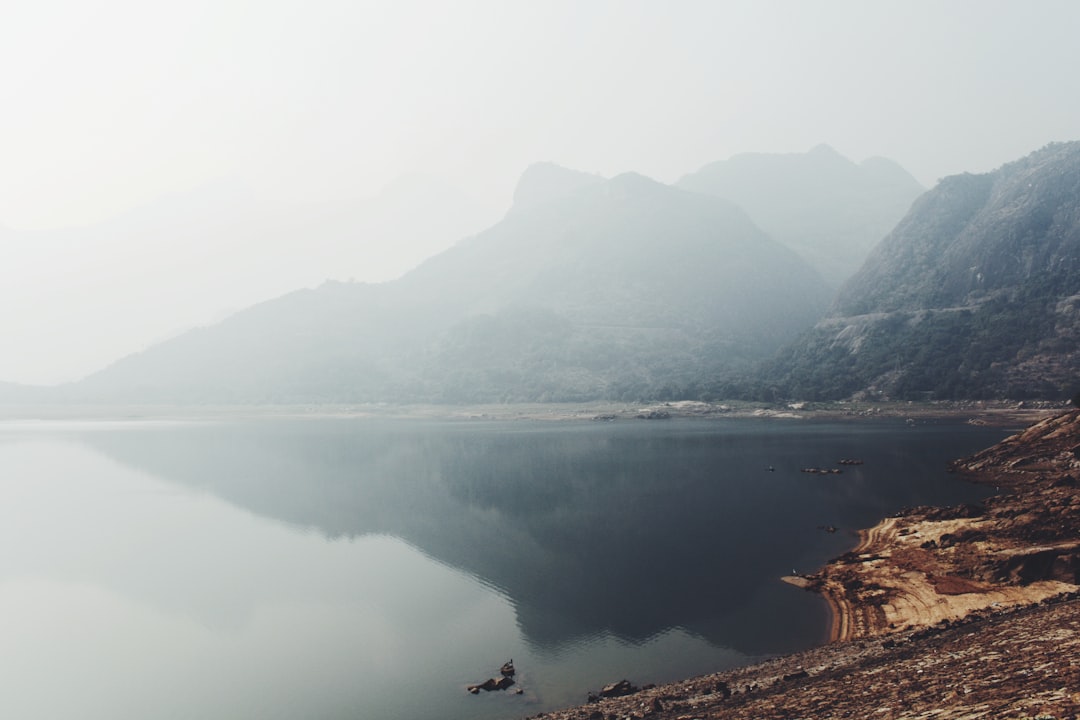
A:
76,420,1001,655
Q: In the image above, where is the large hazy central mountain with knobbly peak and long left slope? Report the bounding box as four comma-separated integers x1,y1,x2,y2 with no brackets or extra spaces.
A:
66,168,827,403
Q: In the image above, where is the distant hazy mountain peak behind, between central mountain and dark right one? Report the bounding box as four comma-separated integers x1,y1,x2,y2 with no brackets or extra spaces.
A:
677,145,924,287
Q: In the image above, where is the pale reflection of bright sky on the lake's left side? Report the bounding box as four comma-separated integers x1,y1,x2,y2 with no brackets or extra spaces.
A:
0,437,527,720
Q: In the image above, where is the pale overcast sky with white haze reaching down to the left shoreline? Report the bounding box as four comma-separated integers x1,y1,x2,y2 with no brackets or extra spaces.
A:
0,0,1080,382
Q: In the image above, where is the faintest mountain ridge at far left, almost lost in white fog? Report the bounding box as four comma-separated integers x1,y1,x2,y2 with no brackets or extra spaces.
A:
0,175,501,383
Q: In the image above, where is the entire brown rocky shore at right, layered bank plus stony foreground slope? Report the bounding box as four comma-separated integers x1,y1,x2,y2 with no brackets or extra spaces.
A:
522,410,1080,720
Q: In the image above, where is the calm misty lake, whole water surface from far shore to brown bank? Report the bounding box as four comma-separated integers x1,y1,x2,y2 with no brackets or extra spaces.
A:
0,418,1008,720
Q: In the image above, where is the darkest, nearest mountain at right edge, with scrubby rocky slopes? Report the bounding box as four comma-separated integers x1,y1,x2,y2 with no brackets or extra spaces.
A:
765,142,1080,398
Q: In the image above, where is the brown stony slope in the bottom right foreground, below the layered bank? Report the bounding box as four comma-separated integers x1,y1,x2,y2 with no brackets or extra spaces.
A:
522,594,1080,720
